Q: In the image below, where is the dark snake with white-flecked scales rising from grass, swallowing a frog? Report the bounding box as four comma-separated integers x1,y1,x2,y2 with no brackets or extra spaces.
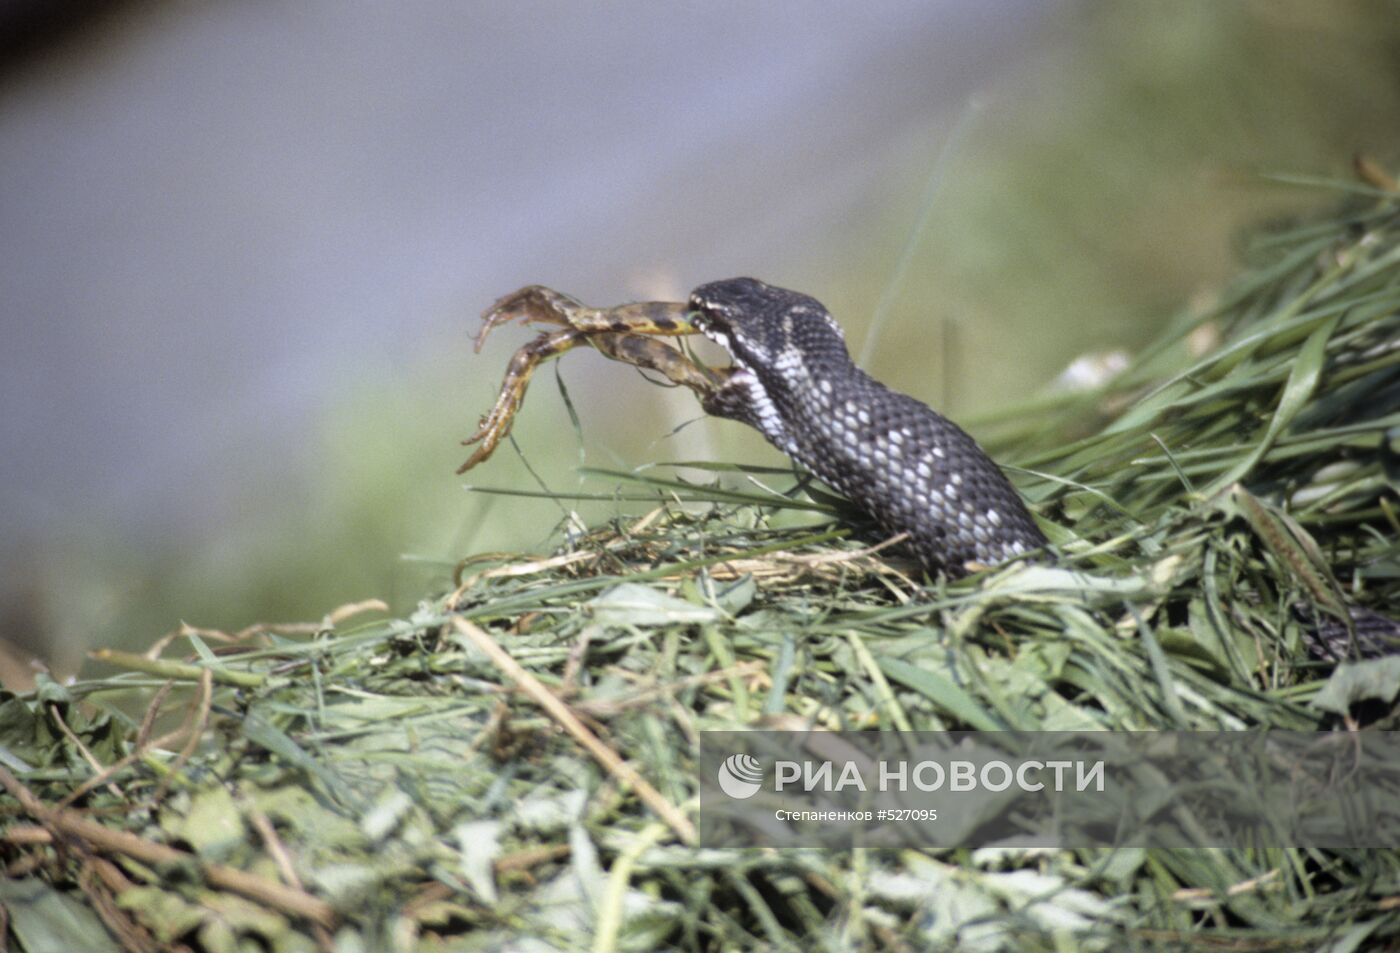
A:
689,278,1046,577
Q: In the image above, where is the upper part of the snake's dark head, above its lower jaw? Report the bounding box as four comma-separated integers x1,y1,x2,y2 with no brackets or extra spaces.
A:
690,278,850,378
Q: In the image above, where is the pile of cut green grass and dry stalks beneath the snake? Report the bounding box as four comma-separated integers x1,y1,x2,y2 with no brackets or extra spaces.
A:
0,176,1400,953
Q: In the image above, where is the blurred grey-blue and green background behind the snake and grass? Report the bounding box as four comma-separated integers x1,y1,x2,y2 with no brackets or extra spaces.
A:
0,0,1400,686
